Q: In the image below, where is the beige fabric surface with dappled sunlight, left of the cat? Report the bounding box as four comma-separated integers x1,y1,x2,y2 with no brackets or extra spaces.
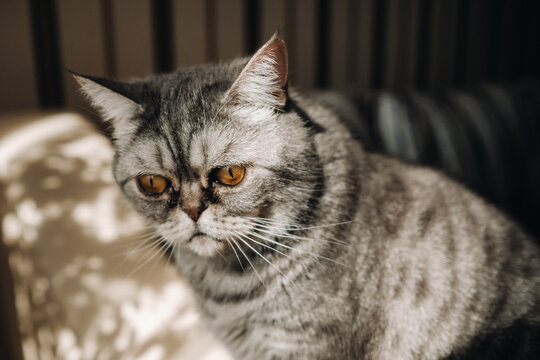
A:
0,113,229,360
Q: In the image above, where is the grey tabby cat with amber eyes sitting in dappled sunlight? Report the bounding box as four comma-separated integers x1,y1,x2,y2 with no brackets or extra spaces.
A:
76,36,540,359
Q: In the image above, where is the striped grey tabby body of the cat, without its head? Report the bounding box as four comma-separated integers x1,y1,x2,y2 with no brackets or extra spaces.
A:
177,93,540,359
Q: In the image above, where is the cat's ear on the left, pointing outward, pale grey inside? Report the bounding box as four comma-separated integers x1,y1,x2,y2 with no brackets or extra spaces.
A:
72,73,143,131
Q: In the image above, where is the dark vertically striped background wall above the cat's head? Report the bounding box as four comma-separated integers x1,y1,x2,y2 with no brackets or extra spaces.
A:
0,0,540,111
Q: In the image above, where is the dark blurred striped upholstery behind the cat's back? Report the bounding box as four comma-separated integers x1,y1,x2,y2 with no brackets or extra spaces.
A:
370,81,540,236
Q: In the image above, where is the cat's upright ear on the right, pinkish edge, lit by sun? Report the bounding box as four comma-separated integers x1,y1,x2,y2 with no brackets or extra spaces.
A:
226,34,289,110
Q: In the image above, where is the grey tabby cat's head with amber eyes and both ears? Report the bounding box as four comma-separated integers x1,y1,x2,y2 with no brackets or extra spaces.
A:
76,36,322,256
